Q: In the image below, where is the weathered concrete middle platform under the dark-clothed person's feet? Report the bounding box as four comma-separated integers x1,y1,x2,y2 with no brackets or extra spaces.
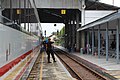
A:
41,54,76,80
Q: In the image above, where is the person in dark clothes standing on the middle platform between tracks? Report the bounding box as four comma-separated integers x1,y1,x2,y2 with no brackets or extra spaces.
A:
46,38,56,63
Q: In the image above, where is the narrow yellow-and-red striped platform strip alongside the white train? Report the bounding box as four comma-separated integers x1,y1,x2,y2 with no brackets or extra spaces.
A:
0,49,39,80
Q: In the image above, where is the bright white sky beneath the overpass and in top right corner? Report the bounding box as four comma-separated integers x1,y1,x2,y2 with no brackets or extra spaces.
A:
41,0,120,36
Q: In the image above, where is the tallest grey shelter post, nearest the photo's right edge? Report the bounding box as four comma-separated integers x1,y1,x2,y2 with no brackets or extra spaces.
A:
116,19,119,64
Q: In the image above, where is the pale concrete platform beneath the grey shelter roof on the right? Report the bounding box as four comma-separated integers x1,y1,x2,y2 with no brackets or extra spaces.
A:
56,46,120,80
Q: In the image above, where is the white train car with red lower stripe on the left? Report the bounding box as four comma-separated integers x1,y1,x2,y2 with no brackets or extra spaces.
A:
0,23,39,76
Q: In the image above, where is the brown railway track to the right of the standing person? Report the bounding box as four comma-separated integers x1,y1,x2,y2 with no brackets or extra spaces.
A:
56,50,111,80
